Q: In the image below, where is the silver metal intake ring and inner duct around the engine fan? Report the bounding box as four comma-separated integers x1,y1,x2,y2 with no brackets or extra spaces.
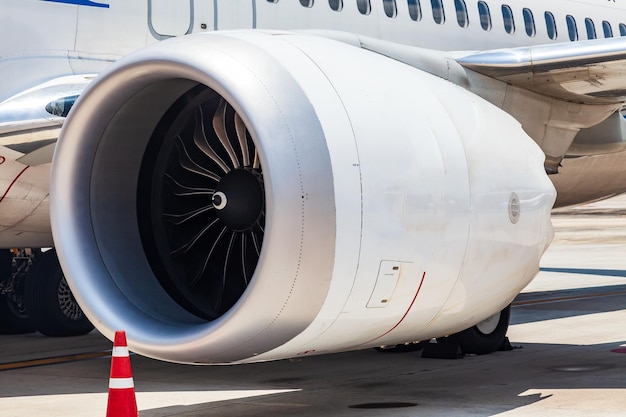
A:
51,33,336,363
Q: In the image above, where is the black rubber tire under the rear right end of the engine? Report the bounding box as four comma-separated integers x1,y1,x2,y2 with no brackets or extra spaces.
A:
448,305,511,355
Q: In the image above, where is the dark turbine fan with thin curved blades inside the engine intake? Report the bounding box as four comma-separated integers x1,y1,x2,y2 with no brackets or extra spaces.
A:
138,86,265,320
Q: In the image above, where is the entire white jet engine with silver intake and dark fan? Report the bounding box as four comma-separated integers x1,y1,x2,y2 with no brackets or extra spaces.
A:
51,31,555,363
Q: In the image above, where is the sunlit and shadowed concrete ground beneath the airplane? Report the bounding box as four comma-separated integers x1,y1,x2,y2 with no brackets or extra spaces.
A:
0,197,626,417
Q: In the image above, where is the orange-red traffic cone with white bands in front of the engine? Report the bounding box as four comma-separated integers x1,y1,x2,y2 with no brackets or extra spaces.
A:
106,330,139,417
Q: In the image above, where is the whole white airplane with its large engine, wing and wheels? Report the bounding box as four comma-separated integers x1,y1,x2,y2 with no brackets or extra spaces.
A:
0,0,626,364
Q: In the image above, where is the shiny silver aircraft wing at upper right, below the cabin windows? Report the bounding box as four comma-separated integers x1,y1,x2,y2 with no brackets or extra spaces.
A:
457,37,626,104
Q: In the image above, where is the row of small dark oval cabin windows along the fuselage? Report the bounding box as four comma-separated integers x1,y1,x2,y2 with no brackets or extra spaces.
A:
267,0,626,41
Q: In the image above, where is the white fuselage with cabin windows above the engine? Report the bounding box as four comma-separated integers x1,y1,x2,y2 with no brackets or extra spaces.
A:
0,0,626,102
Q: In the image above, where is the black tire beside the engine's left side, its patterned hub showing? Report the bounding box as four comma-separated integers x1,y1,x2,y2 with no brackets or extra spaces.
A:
25,250,93,336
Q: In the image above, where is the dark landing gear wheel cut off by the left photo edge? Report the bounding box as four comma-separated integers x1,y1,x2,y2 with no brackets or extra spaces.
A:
0,249,34,334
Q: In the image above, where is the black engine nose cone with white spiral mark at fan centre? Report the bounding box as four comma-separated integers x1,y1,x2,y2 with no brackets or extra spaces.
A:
213,169,264,231
